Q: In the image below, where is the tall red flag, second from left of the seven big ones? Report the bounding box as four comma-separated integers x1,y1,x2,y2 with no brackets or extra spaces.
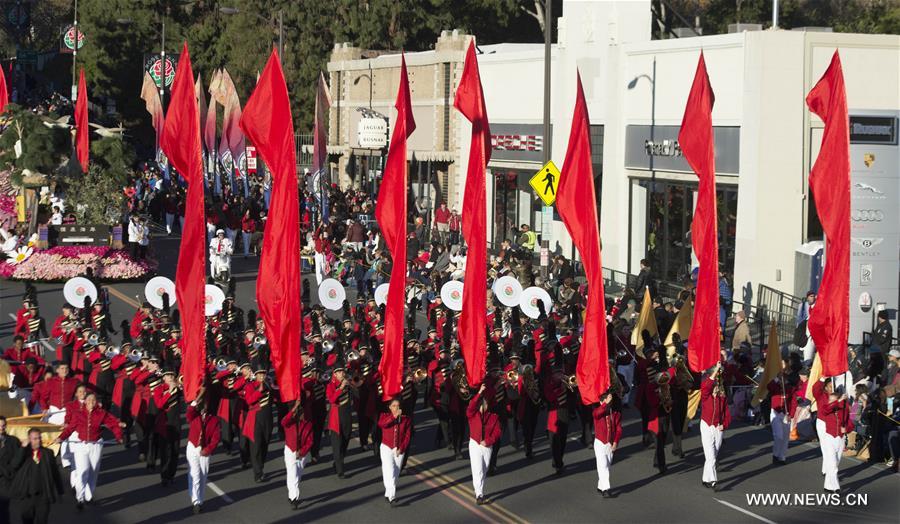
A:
240,49,302,402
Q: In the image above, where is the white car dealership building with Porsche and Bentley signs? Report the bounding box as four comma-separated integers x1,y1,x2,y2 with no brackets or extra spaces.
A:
332,0,900,342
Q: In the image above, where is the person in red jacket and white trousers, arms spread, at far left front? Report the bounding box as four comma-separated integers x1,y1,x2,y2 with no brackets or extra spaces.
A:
54,393,124,511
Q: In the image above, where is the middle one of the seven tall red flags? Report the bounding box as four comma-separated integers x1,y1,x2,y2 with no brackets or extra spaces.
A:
453,39,491,387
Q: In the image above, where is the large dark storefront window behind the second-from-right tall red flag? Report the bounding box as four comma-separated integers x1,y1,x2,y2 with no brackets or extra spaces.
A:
634,180,737,282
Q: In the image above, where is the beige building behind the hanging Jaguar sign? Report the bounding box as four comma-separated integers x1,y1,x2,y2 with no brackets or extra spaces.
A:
328,31,471,208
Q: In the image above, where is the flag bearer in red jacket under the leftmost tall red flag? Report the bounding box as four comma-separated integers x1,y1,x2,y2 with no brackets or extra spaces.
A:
184,386,221,514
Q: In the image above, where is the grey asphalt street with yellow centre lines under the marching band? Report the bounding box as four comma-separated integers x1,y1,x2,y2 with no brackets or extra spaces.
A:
0,239,900,523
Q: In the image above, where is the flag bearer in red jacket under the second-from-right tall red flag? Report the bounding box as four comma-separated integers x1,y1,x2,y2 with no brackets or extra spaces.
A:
700,362,731,491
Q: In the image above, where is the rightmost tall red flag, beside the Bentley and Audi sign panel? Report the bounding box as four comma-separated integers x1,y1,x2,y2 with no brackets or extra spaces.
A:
806,50,850,377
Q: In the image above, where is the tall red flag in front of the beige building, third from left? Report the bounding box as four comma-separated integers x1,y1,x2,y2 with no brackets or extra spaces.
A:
375,56,416,400
